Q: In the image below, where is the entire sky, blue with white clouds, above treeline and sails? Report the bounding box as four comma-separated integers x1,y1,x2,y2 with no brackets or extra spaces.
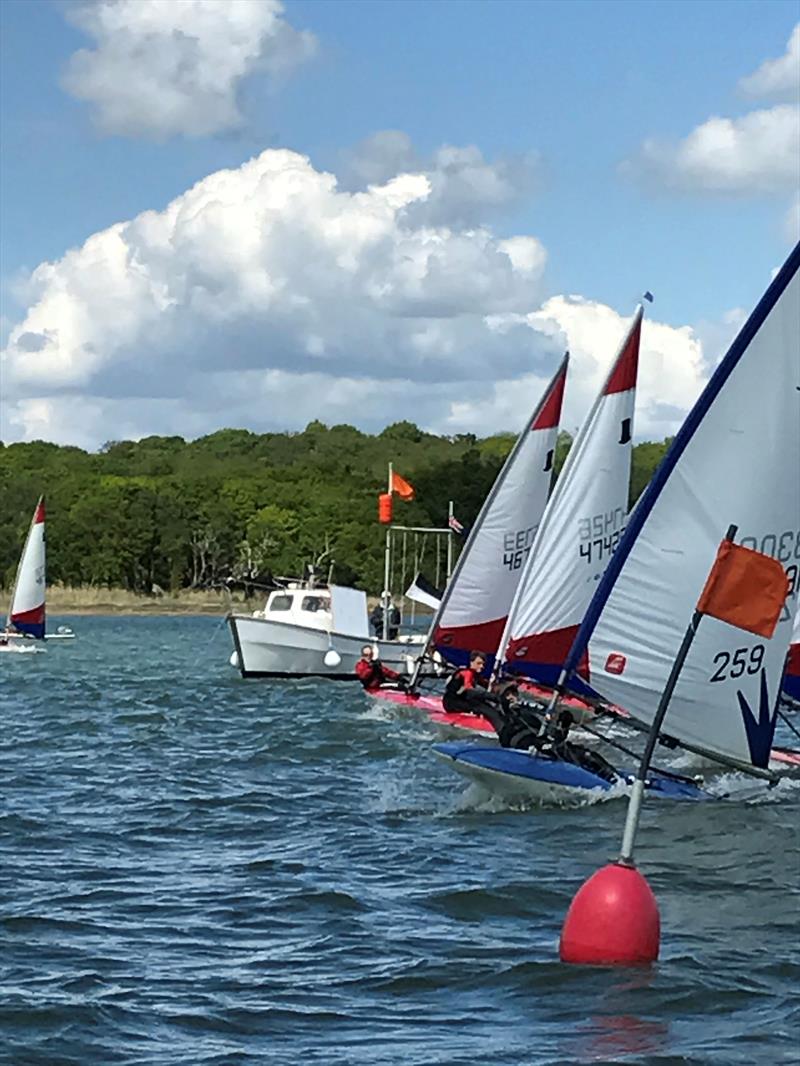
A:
0,0,800,449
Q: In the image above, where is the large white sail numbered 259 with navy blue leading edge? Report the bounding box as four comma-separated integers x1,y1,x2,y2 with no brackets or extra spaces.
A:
567,244,800,768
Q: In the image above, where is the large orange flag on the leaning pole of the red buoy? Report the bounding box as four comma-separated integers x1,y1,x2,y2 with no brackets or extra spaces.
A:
698,540,789,640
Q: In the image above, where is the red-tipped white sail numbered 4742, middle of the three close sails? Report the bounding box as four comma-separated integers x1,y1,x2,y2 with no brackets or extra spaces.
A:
502,306,642,684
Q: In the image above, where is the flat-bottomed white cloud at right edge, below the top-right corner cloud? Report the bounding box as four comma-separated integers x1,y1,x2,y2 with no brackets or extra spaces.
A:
623,104,800,194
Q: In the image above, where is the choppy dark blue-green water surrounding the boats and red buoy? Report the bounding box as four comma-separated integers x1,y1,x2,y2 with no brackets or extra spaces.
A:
0,618,800,1066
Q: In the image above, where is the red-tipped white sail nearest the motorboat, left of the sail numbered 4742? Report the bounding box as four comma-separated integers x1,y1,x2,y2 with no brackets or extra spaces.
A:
432,355,569,664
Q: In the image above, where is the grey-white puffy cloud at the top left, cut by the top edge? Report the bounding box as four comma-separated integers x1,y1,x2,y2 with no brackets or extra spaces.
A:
63,0,316,140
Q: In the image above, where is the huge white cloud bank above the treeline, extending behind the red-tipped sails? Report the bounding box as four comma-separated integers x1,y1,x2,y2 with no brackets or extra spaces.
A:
0,144,706,448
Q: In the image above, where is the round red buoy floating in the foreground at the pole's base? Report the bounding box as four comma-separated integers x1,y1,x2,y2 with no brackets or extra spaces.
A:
559,862,661,966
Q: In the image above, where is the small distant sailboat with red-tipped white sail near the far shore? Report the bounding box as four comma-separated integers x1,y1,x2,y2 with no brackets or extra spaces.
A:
0,496,75,651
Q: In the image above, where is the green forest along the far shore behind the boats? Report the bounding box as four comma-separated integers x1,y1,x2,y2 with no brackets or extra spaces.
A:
0,422,668,593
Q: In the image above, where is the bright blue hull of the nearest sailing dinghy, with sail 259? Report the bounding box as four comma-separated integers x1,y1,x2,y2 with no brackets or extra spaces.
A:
433,741,714,800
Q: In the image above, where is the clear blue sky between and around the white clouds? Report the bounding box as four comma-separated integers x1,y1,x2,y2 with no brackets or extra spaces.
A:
0,0,800,438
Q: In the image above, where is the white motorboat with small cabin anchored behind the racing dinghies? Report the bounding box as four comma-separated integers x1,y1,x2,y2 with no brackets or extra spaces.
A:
227,582,425,681
